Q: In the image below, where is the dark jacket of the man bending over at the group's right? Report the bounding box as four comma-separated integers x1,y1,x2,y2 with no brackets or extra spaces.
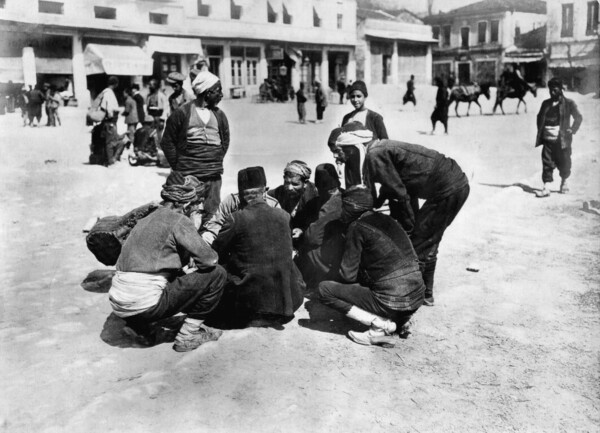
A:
365,140,468,231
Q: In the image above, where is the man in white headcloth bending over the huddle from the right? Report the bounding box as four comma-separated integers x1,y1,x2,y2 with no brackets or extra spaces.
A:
336,124,469,306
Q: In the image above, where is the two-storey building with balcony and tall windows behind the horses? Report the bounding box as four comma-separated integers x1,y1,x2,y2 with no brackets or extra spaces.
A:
424,0,547,84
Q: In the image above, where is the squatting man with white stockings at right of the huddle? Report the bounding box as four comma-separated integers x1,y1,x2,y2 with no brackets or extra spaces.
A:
319,185,425,346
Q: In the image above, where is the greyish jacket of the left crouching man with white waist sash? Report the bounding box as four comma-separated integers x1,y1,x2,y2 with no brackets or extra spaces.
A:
117,207,218,275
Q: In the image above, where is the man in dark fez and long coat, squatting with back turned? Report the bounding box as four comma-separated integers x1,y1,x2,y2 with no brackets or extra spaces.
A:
213,167,304,326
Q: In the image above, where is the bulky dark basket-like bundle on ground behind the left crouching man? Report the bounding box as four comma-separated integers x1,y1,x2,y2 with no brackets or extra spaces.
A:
85,202,159,266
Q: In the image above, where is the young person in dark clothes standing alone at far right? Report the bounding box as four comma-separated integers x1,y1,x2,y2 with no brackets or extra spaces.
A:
535,78,583,197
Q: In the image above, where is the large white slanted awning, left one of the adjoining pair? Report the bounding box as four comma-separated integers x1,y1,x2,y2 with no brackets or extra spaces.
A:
83,44,154,75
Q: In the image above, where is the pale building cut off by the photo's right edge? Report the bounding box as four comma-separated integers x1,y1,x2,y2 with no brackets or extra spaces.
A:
547,0,600,94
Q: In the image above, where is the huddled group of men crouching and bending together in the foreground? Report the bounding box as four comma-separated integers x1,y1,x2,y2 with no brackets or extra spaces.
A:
109,122,469,352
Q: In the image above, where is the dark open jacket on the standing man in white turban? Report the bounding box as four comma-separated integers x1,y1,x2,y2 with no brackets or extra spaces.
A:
160,101,229,179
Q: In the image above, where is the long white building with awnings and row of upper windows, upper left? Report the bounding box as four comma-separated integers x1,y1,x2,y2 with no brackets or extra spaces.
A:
0,0,356,104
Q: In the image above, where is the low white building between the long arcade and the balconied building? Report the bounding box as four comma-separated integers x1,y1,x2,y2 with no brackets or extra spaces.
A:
356,8,437,85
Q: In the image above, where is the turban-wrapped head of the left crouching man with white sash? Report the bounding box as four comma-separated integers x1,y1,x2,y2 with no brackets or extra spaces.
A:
160,170,206,213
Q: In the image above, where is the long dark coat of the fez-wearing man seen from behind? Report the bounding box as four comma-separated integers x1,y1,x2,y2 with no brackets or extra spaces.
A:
213,201,303,317
